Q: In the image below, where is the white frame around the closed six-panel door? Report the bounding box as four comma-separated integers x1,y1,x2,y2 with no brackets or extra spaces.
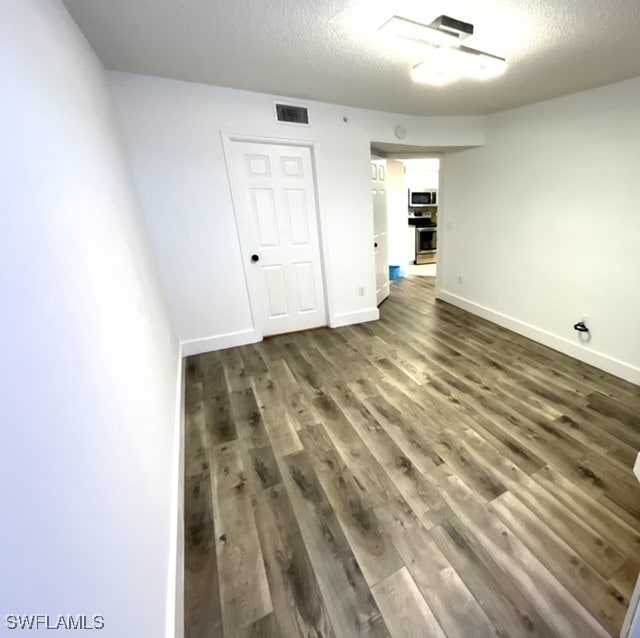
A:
220,131,332,341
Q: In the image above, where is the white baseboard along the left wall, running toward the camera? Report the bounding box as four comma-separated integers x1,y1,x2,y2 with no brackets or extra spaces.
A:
165,344,185,638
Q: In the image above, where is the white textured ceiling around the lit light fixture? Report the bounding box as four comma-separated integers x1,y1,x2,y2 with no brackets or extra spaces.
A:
64,0,640,115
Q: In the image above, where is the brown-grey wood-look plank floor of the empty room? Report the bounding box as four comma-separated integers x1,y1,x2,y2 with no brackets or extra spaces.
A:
185,277,640,638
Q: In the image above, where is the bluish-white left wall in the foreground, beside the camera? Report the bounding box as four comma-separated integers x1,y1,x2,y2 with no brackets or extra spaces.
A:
0,0,178,638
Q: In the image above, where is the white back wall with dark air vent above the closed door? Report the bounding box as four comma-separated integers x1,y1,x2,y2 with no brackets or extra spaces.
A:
110,73,485,352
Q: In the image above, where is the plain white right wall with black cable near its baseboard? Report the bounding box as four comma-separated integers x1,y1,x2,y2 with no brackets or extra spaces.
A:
438,79,640,382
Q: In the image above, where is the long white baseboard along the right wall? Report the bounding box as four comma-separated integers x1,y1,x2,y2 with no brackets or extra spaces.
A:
436,290,640,384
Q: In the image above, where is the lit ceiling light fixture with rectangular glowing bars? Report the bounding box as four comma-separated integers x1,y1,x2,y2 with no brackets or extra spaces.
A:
379,15,507,86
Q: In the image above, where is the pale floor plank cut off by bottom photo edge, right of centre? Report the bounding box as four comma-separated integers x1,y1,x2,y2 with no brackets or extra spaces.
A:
371,567,445,638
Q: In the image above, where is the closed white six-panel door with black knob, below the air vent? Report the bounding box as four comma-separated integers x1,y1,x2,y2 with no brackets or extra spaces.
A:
228,141,327,336
